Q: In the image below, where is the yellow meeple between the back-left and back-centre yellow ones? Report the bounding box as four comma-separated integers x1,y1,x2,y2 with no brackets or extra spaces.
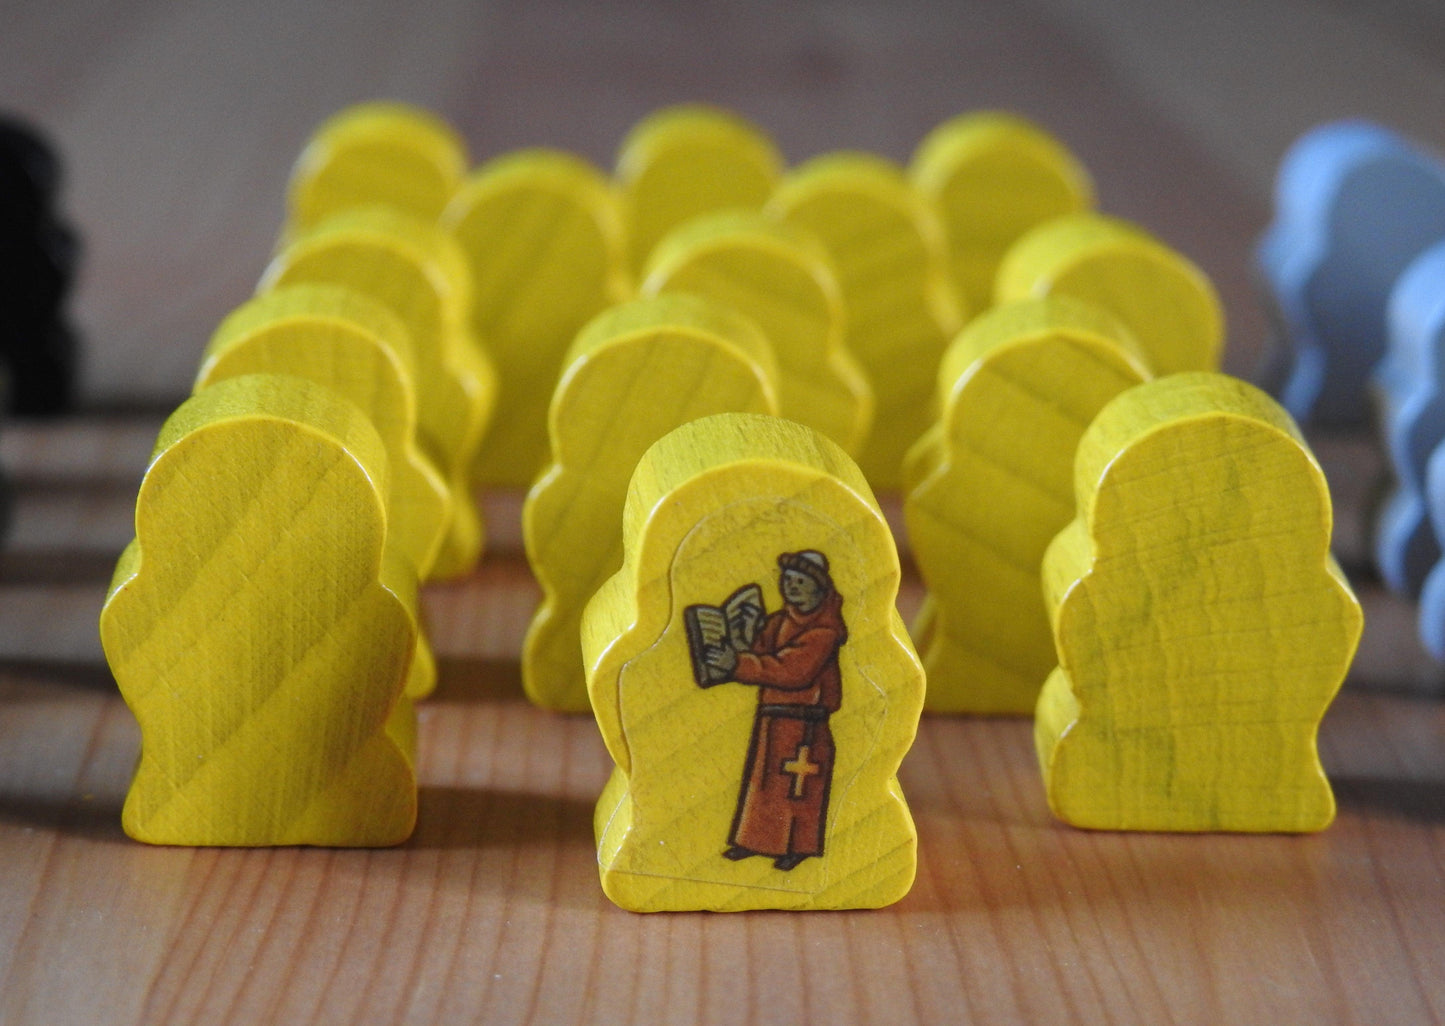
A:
442,150,631,487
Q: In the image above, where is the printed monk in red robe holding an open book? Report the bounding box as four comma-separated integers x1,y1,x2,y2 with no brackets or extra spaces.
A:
683,551,848,870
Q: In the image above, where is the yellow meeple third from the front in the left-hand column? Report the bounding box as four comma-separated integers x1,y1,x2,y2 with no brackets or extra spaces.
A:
257,207,497,577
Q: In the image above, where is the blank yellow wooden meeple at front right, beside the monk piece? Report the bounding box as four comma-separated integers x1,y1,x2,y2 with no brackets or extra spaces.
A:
1035,373,1363,831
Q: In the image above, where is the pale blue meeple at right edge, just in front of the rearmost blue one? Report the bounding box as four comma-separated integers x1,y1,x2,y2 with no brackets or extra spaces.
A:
1374,240,1445,598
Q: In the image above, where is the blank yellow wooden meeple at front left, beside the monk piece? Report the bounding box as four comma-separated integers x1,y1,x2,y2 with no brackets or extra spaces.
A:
100,374,416,845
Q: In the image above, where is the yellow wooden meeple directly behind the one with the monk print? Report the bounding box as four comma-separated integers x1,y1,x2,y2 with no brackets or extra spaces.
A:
522,292,777,712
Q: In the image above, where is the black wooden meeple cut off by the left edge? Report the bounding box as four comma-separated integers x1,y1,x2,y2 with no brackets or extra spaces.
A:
0,116,79,413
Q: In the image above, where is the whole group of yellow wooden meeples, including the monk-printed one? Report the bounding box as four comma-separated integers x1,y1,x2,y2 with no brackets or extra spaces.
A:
101,104,1360,909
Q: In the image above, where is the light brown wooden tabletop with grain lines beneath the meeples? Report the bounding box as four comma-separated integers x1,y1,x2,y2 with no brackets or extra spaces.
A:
0,418,1445,1026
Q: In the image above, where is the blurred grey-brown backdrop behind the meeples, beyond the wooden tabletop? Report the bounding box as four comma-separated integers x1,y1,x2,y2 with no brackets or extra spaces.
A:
0,0,1445,408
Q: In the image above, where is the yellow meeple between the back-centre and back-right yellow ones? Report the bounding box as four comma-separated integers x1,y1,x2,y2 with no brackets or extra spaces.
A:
767,153,964,490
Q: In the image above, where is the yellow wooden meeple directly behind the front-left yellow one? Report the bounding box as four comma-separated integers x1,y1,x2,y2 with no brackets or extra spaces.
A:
195,285,452,698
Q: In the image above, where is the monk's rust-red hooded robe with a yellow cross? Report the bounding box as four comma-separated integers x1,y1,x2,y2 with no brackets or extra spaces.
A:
728,591,848,857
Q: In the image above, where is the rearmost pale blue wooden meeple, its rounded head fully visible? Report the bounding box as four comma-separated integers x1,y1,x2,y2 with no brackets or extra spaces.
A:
1256,121,1445,426
